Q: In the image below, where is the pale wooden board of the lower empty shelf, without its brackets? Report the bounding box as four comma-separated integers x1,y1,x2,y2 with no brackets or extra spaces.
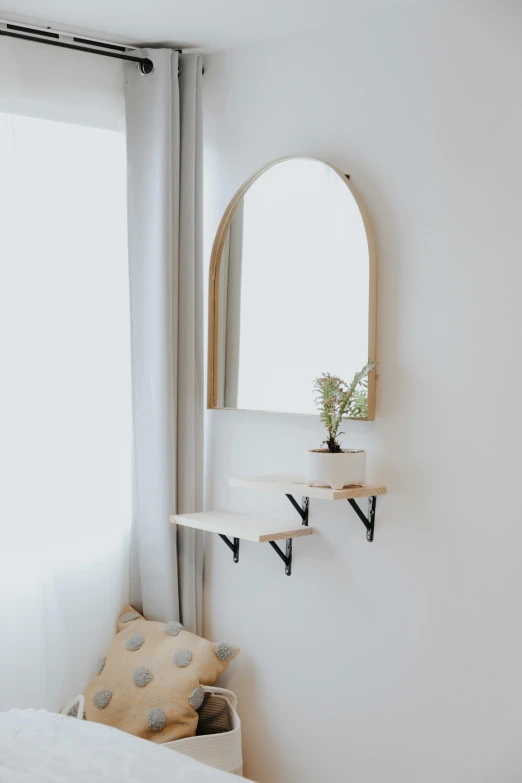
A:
170,511,314,542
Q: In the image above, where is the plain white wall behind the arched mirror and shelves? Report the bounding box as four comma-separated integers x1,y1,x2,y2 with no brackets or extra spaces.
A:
201,2,522,783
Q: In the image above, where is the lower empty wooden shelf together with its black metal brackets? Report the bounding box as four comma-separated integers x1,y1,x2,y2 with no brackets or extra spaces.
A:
170,511,314,576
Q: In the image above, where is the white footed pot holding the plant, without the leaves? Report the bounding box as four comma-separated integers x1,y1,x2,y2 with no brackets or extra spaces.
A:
306,449,366,489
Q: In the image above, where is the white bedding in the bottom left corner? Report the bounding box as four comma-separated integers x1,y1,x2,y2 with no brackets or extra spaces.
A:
0,710,244,783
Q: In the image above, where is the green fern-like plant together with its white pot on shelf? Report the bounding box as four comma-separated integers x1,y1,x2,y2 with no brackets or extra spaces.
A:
307,362,375,489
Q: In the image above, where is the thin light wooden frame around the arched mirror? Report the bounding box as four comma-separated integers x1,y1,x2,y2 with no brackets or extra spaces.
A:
207,155,377,421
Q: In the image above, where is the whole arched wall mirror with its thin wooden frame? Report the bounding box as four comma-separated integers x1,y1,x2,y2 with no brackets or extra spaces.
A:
208,158,376,419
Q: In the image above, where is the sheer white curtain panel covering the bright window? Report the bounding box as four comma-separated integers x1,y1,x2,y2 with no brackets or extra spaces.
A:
0,39,132,709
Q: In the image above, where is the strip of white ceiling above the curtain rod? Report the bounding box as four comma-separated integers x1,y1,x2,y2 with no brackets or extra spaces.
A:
0,0,410,51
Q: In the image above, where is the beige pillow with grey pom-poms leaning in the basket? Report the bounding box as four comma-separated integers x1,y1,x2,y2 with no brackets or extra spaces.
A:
84,606,239,743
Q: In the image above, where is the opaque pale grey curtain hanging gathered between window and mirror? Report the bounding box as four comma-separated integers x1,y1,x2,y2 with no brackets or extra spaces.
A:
126,49,203,633
